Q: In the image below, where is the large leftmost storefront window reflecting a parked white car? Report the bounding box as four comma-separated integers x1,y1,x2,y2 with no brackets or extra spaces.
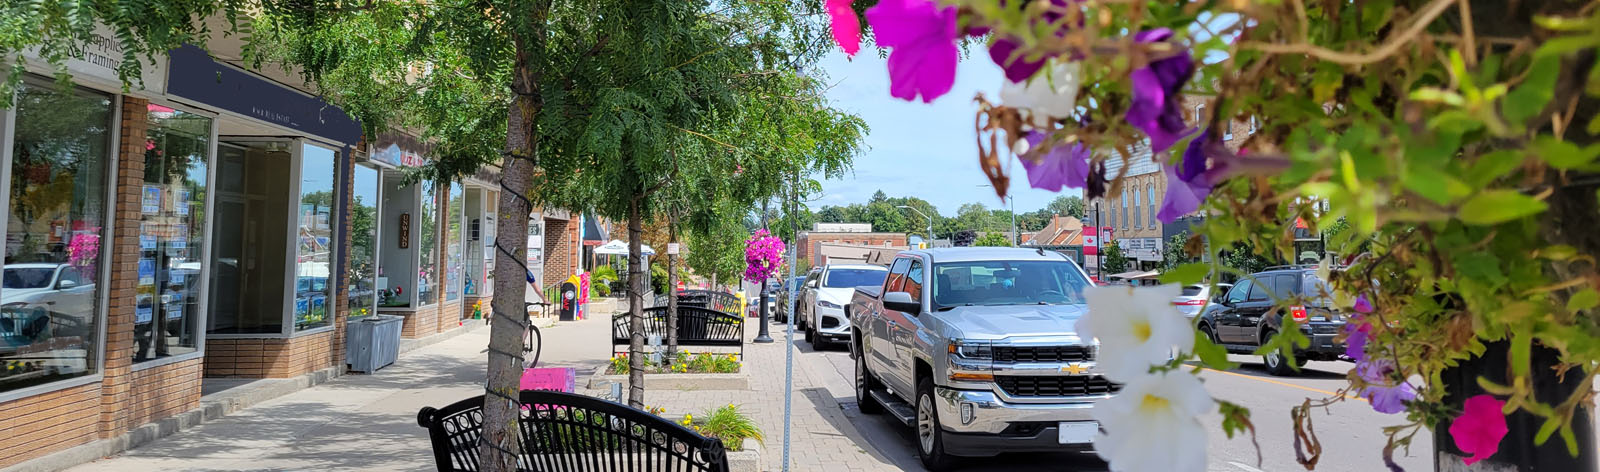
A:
0,77,112,390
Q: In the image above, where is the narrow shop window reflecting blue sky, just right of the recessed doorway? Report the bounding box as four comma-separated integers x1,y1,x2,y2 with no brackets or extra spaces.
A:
294,144,338,331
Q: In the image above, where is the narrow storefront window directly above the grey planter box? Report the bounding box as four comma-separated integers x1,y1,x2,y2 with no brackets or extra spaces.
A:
346,165,378,318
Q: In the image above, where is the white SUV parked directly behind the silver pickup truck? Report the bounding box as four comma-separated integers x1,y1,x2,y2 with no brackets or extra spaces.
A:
795,264,890,349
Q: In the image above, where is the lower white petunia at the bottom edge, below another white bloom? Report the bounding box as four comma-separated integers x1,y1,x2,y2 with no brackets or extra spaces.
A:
1093,371,1216,472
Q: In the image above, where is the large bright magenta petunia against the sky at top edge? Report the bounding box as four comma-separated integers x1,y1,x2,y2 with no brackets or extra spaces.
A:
867,0,962,102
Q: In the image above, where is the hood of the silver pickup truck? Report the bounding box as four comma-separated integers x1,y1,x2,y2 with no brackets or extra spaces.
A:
938,304,1088,339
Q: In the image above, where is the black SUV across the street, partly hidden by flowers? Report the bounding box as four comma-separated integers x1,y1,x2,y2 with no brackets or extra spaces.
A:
1200,266,1344,376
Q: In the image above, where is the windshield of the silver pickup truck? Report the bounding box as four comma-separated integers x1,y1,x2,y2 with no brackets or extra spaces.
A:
933,261,1090,307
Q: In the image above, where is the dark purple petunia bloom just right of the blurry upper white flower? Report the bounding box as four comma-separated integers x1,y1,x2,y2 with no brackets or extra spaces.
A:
1126,27,1195,152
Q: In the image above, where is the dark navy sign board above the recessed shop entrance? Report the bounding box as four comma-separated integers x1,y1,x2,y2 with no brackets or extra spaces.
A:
166,45,362,144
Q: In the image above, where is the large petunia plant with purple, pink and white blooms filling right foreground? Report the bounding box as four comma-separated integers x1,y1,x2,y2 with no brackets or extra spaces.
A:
827,0,1600,470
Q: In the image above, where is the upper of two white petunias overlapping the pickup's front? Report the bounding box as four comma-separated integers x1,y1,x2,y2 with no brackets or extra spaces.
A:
1075,283,1195,382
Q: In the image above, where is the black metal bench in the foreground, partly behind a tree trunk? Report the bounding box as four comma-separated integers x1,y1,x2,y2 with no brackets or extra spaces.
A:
416,390,728,472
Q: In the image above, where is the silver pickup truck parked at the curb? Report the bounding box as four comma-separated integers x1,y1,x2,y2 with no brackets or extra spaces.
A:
848,248,1120,470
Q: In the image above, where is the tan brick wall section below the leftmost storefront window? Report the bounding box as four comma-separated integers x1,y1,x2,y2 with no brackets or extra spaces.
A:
0,384,102,467
